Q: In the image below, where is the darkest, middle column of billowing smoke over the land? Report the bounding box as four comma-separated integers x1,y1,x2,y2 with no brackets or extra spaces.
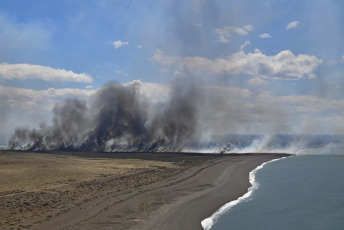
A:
83,83,147,151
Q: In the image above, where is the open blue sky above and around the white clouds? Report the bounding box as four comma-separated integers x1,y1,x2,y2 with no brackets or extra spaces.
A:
0,0,344,89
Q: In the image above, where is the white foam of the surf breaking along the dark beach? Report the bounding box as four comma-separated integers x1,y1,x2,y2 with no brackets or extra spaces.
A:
201,157,286,230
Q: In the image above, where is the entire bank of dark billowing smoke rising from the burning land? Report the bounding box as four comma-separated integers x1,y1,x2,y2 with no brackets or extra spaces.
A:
8,79,202,151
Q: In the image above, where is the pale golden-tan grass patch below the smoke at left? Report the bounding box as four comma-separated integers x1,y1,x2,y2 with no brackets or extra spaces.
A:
0,152,176,196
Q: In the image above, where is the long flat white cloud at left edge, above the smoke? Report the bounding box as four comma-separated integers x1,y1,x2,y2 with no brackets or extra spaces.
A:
0,63,93,83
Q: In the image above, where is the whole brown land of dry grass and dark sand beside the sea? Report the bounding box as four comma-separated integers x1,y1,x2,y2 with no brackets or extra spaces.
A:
0,152,285,230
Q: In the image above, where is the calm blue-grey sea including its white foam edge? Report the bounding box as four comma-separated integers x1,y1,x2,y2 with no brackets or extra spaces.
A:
202,146,344,230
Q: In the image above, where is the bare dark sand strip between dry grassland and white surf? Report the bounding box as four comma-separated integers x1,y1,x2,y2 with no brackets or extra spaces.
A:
31,154,287,230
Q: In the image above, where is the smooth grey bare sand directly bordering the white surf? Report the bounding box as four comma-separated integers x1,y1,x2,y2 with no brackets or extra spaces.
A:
133,154,289,230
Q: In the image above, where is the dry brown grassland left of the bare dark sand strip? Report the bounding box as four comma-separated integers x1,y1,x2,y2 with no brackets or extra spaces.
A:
0,151,197,229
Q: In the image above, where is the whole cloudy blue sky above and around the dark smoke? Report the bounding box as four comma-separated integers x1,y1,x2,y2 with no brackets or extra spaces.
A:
0,0,344,144
